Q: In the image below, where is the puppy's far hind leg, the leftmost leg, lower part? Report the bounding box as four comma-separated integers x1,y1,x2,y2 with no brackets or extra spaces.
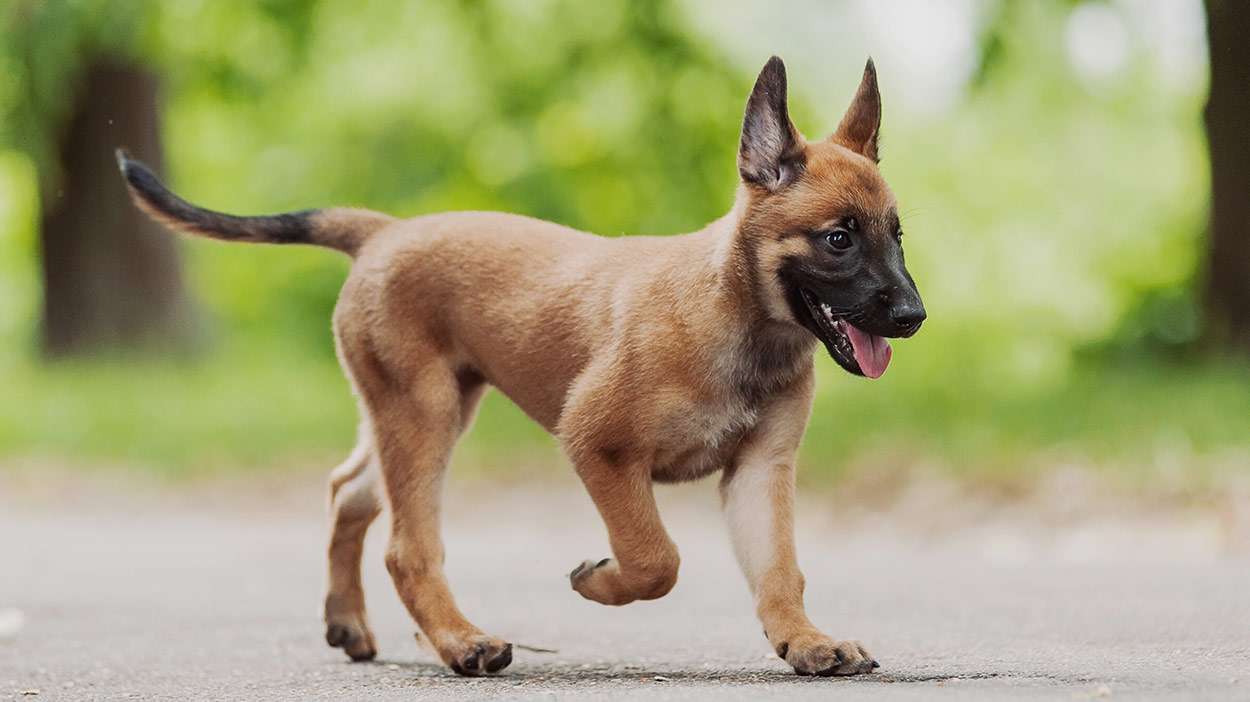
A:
325,420,381,661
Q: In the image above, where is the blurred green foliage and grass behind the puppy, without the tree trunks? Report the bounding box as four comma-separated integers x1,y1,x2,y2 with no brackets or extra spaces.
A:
0,0,1250,475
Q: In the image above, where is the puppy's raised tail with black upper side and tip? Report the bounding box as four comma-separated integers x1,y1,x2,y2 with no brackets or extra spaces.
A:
116,149,395,257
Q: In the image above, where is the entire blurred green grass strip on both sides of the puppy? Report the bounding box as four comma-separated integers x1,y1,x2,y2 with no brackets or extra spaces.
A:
0,345,1250,482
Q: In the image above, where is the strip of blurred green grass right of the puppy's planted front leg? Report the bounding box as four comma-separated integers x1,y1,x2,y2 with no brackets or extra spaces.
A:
803,361,1250,485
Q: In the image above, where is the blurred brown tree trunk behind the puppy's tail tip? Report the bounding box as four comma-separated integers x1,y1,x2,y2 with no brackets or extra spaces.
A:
43,64,198,356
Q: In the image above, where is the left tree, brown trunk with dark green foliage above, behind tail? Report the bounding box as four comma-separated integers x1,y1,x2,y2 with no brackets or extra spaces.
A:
0,1,196,356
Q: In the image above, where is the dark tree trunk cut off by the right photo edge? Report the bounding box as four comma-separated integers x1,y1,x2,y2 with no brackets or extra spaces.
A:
1205,0,1250,353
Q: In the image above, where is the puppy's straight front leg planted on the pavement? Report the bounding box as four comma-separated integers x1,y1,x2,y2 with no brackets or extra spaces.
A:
720,379,879,676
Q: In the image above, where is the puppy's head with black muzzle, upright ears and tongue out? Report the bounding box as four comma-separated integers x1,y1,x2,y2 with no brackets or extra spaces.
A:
736,56,925,377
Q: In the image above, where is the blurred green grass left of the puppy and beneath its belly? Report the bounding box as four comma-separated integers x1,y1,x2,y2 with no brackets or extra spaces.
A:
0,345,556,477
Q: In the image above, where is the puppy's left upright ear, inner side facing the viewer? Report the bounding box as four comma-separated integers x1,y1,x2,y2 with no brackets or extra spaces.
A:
738,56,804,191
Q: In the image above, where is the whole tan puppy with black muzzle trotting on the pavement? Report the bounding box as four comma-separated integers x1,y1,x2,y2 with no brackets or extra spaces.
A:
118,56,925,676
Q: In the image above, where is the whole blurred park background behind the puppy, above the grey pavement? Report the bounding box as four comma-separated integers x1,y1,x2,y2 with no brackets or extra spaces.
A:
0,0,1250,493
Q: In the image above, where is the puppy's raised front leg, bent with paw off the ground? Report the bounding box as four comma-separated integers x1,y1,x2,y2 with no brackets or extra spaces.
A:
569,451,681,605
